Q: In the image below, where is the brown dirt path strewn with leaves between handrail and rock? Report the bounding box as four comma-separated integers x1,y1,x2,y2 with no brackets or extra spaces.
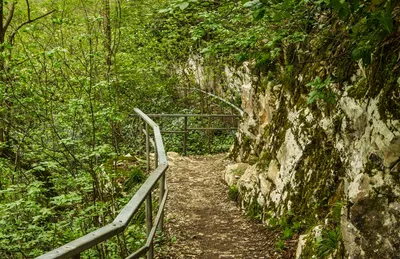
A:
157,152,296,259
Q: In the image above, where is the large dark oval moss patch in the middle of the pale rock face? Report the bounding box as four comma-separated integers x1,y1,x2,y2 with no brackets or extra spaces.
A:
288,128,344,231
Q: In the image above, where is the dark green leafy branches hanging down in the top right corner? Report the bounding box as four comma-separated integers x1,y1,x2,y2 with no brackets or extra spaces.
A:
244,0,398,68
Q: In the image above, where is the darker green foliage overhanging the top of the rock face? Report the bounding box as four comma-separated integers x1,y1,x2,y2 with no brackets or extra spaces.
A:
161,0,400,117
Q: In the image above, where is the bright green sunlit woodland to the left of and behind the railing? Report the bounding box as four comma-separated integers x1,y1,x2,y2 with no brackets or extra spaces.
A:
0,0,239,258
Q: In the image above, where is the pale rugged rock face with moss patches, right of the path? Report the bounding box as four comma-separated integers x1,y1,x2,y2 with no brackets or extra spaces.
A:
224,66,400,259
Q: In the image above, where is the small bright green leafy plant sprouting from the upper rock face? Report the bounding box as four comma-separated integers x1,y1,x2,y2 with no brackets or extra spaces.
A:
307,76,336,104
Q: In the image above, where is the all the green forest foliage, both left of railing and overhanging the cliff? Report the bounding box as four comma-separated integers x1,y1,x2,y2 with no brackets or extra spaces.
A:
0,0,400,258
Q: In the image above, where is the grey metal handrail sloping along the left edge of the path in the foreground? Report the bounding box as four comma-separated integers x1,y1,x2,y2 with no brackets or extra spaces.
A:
36,108,168,259
